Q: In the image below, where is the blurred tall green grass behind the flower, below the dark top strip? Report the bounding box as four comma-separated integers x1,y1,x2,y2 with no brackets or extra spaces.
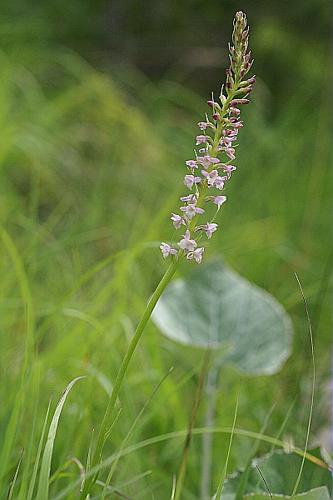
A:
0,37,330,500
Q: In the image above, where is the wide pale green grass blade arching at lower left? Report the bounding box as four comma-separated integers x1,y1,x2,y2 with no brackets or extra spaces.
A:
36,377,84,500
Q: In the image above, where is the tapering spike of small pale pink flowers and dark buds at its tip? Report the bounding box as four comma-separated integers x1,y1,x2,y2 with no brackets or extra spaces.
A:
160,12,255,264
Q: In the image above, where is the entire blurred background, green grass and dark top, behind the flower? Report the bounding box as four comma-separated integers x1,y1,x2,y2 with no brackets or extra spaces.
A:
0,0,332,499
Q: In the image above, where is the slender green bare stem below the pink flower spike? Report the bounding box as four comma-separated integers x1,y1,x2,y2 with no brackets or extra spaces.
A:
81,258,182,499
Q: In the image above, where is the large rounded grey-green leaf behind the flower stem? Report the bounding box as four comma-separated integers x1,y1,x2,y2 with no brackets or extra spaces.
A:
153,261,292,375
